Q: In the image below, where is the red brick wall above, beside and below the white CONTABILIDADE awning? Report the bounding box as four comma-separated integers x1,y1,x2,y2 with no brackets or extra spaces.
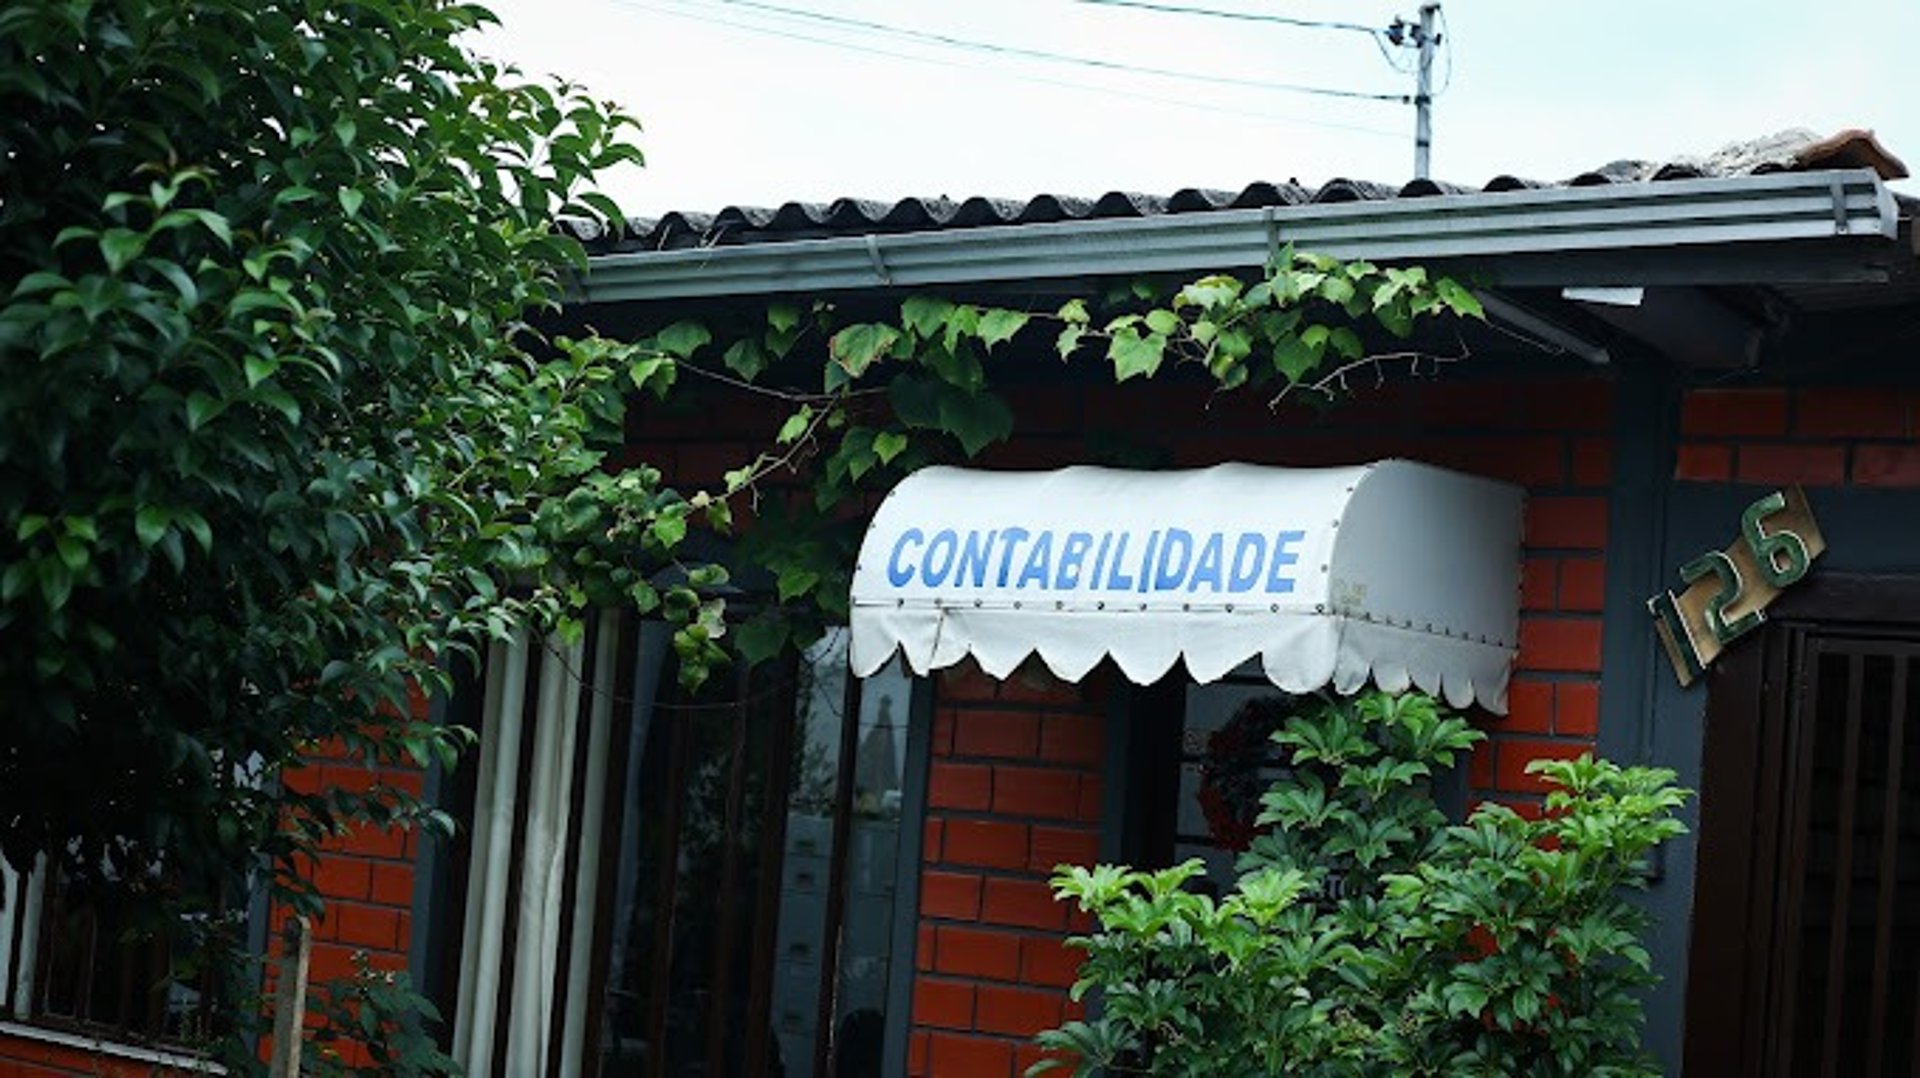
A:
634,377,1613,1078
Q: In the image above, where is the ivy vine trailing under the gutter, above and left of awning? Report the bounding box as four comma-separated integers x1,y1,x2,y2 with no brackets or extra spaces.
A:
563,246,1484,688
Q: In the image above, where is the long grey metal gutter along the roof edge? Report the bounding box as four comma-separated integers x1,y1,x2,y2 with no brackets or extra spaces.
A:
572,169,1899,304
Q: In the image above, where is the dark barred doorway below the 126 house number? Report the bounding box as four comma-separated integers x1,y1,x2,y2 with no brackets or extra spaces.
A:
1686,576,1920,1076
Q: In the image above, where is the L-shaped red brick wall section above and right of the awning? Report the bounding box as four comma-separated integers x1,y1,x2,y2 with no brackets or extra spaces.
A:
1044,377,1613,813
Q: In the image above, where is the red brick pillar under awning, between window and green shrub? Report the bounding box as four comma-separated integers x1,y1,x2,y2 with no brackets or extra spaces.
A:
908,665,1106,1074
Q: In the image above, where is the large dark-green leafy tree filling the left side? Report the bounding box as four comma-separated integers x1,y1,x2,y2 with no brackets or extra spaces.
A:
0,0,656,1060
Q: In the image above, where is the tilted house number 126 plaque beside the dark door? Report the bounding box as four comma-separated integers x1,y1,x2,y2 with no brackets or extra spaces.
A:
1647,488,1826,684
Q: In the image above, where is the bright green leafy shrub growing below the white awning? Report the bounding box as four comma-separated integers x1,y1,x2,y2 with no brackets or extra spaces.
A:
1029,692,1690,1076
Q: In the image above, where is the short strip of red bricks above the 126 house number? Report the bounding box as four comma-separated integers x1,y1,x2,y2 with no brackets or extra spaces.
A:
1674,388,1920,486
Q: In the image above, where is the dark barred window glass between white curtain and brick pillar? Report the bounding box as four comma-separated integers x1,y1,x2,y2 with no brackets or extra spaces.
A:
599,628,912,1078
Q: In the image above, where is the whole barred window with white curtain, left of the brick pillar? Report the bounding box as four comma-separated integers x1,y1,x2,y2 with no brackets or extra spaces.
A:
432,615,912,1078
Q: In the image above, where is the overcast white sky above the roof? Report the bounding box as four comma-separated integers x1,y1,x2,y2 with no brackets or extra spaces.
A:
478,0,1920,217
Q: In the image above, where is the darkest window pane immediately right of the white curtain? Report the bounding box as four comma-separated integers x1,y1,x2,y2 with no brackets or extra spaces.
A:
601,626,793,1074
